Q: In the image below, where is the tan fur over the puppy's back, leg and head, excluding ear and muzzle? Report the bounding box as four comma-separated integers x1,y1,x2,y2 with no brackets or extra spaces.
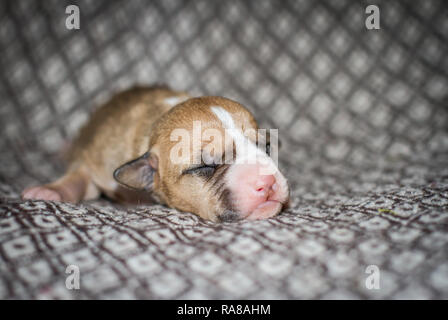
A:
22,87,264,221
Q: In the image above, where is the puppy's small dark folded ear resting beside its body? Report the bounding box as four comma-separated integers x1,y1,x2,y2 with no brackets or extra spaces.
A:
114,152,157,190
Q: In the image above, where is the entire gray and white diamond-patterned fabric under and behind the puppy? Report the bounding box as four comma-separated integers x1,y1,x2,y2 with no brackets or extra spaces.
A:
0,0,448,299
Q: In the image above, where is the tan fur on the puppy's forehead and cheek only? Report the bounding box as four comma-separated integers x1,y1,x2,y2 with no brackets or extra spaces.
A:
149,97,257,220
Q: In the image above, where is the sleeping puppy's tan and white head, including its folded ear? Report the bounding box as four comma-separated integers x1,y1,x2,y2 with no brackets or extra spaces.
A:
114,97,289,221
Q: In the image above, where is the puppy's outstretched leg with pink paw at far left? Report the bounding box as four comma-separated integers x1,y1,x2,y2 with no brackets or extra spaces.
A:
22,168,100,203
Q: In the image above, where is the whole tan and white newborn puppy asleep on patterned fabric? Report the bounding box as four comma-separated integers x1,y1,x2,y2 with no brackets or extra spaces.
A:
22,87,289,221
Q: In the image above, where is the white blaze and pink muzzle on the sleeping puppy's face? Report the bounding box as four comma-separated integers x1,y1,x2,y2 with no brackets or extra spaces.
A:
211,106,289,218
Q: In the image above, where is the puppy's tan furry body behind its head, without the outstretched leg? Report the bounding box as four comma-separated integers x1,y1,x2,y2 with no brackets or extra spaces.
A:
69,87,189,202
